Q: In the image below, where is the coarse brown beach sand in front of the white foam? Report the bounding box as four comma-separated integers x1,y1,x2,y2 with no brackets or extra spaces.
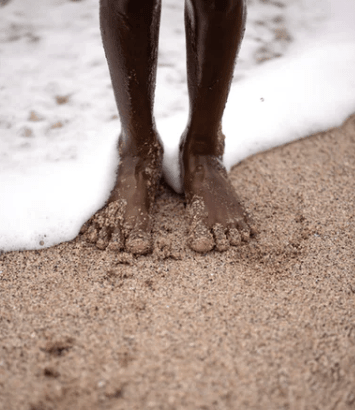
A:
0,116,355,410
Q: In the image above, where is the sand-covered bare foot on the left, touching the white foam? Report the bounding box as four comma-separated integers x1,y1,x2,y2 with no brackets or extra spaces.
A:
81,136,163,254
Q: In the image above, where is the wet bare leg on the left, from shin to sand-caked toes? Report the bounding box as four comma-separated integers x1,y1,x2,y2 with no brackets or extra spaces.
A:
81,0,163,253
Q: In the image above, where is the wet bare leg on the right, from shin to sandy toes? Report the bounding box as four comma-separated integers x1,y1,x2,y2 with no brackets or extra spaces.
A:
180,0,250,252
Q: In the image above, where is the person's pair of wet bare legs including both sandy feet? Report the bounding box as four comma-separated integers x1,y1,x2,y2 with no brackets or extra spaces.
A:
84,0,250,254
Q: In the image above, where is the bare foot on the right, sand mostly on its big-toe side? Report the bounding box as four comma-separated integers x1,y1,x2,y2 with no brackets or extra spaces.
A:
183,150,251,253
